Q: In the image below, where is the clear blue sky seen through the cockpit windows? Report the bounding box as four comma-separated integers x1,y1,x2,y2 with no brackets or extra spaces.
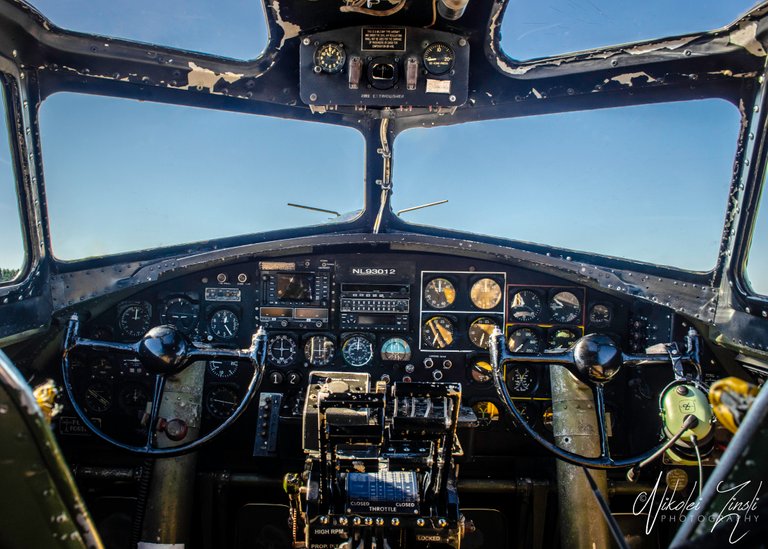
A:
0,0,768,288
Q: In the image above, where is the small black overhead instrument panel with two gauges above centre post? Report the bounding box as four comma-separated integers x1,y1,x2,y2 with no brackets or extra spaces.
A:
300,26,469,109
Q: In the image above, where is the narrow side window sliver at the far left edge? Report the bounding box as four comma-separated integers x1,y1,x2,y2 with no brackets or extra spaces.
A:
0,86,25,284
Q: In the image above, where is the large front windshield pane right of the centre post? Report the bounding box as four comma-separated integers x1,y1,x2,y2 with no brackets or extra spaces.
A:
392,100,739,271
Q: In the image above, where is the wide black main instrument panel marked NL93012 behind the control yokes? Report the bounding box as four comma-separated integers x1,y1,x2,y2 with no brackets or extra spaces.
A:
71,253,672,448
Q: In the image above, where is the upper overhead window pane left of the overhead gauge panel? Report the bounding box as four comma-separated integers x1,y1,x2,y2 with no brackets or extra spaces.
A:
24,0,267,59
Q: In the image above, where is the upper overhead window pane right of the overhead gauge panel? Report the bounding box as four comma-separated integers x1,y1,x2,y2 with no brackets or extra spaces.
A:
501,0,759,60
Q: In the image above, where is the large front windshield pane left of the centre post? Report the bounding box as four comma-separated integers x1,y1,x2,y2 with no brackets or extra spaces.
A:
40,94,364,260
